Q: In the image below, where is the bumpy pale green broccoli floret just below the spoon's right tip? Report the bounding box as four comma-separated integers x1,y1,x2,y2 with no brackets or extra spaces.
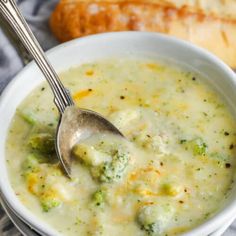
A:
95,150,129,182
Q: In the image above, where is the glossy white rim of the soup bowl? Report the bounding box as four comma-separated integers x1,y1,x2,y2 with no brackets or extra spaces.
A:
0,31,236,236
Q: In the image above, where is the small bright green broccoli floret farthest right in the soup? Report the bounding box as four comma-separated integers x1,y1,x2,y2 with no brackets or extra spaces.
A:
180,138,208,155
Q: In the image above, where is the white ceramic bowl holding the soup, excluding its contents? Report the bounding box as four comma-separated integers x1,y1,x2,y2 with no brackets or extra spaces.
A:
0,32,236,236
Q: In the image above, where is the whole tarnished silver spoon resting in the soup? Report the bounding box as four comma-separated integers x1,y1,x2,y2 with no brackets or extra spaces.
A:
0,0,123,177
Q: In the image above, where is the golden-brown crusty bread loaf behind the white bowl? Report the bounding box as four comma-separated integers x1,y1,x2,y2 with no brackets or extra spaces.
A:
50,0,236,68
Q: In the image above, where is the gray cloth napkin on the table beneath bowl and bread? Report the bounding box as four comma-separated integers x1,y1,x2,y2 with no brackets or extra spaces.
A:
0,0,236,236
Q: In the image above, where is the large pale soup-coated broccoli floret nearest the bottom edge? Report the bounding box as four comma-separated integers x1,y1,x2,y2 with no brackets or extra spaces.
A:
137,204,174,236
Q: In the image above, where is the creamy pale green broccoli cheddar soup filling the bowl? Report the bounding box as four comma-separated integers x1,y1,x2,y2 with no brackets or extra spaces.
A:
6,59,236,236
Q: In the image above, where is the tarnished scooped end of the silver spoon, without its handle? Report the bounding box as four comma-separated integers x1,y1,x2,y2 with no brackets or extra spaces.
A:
56,106,124,176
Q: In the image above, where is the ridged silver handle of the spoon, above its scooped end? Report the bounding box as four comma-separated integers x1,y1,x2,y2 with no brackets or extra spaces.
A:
0,0,74,113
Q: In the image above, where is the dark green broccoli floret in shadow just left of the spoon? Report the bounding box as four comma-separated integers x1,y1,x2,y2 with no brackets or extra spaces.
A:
28,133,55,154
